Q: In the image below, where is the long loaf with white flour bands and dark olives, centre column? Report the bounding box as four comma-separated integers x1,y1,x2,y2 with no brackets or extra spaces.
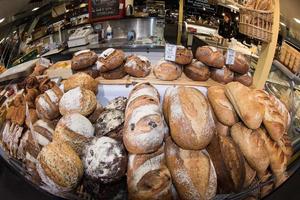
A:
123,84,167,154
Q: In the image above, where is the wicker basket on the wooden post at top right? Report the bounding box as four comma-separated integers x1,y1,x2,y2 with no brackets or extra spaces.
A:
239,8,273,43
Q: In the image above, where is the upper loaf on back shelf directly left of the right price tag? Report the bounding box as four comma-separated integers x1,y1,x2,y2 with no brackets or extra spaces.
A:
195,46,225,69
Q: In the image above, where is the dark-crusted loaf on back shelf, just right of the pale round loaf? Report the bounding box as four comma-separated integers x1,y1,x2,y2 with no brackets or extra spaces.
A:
183,59,210,81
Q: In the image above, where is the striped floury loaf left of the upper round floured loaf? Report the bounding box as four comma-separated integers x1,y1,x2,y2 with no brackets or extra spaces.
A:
35,86,63,120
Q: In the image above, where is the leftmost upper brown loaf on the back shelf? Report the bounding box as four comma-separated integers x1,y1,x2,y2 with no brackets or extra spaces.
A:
71,50,98,70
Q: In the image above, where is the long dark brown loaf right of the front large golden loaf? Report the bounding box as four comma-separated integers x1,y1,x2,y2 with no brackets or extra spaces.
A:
207,135,245,194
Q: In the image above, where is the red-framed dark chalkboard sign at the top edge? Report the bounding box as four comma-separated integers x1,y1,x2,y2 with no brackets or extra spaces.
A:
89,0,125,21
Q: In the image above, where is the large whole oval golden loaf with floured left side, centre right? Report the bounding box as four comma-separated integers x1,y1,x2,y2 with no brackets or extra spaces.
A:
166,87,215,150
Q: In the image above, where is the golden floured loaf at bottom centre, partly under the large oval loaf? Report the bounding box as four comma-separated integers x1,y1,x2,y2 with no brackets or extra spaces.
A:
165,137,217,200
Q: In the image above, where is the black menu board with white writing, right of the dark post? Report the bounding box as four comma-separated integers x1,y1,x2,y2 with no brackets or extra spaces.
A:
185,0,216,15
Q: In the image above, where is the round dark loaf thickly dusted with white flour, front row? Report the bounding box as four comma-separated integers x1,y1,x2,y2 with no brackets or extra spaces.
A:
83,137,127,183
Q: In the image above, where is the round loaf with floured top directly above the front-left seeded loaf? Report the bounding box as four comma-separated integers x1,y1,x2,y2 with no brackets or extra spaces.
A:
53,113,95,155
